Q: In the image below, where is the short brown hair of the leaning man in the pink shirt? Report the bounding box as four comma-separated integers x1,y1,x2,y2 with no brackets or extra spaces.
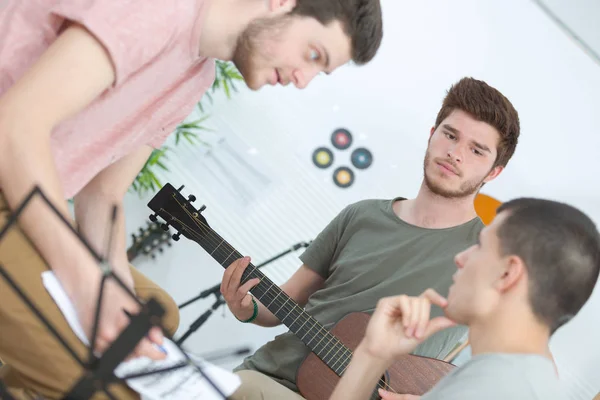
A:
291,0,383,65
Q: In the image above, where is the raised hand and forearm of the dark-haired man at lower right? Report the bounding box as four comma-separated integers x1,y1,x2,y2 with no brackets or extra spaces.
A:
330,289,455,400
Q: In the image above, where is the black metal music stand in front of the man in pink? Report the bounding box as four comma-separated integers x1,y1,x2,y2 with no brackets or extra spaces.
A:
0,186,227,400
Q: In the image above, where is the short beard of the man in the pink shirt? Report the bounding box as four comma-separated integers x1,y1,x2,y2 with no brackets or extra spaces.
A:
232,15,290,90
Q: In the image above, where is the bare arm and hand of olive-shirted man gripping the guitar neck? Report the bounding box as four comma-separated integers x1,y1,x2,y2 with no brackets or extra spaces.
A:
221,258,325,327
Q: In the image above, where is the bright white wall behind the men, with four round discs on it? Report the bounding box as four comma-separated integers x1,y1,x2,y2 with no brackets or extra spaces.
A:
127,0,600,399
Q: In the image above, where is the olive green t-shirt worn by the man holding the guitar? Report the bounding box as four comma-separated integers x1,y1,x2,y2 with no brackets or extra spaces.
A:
235,198,484,391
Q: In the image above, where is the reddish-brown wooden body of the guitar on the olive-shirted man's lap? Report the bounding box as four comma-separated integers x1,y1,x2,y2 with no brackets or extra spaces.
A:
296,313,456,400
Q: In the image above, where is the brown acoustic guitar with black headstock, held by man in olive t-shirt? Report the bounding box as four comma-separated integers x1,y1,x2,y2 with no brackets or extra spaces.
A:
148,183,455,400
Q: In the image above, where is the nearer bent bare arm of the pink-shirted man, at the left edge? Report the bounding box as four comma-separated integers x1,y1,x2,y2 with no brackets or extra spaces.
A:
0,24,162,360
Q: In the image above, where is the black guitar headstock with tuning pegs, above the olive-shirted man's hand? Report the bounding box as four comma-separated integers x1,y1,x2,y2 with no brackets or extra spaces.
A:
148,183,209,242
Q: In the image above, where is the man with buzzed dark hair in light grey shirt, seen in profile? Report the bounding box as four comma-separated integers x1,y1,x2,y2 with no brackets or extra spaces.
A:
331,198,600,400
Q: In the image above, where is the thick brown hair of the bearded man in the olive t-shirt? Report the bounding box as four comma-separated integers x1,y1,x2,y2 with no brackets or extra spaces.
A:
435,78,520,167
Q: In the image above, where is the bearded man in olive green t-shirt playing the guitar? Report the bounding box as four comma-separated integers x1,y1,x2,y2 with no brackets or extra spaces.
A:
221,78,520,400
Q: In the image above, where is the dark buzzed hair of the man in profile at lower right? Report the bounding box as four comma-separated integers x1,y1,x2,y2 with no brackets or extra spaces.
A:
497,198,600,333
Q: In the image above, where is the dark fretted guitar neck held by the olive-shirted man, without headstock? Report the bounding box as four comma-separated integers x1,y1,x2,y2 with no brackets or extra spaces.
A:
194,228,352,376
